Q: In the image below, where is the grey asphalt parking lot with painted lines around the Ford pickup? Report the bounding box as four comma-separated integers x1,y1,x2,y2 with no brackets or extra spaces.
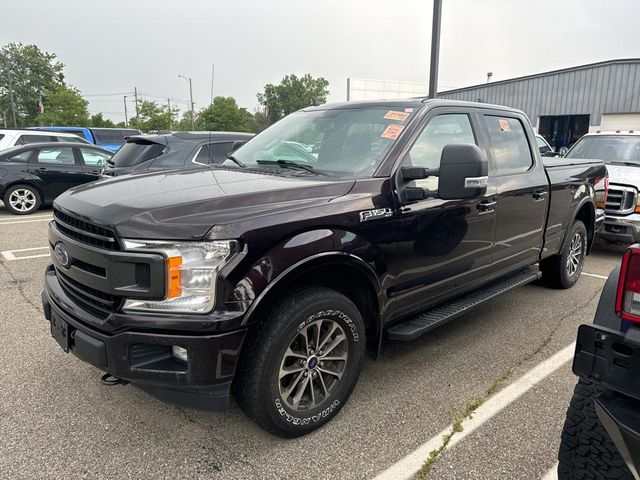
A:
0,204,622,479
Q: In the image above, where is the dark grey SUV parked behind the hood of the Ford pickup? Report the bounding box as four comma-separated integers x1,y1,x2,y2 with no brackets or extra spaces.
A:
102,132,254,177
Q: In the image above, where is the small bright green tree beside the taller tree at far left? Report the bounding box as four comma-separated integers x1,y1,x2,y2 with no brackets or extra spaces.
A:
36,85,89,127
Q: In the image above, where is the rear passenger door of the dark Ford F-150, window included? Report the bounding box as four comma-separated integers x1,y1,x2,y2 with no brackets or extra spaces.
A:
480,110,550,272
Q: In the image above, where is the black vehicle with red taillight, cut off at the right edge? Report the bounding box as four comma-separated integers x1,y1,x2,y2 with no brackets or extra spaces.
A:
558,244,640,480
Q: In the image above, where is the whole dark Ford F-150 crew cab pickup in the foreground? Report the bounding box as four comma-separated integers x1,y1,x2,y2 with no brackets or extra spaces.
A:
43,99,607,437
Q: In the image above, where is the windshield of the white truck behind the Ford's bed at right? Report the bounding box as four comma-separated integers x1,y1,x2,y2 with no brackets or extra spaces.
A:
566,135,640,167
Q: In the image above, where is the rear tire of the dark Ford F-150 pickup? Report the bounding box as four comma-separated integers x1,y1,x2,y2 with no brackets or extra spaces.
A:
540,220,587,288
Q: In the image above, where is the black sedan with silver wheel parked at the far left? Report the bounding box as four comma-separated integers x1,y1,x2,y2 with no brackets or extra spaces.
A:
0,142,113,215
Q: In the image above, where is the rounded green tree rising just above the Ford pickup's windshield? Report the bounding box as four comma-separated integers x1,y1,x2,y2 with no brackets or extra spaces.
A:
257,73,329,123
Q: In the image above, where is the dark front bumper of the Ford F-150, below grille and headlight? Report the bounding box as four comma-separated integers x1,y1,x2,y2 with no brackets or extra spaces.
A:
42,268,246,410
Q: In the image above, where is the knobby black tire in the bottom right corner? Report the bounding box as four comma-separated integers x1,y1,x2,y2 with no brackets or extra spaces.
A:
558,380,633,480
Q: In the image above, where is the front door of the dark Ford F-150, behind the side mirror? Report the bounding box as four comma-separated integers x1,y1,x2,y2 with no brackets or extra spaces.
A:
392,108,496,315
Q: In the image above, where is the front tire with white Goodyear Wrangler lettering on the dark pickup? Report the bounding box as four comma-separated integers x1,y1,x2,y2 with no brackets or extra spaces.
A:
234,287,366,438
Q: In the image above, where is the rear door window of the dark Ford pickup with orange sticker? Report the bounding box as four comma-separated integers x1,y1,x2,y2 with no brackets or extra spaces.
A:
484,115,533,175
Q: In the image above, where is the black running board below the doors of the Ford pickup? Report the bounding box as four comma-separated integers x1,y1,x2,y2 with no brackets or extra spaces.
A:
387,268,542,342
